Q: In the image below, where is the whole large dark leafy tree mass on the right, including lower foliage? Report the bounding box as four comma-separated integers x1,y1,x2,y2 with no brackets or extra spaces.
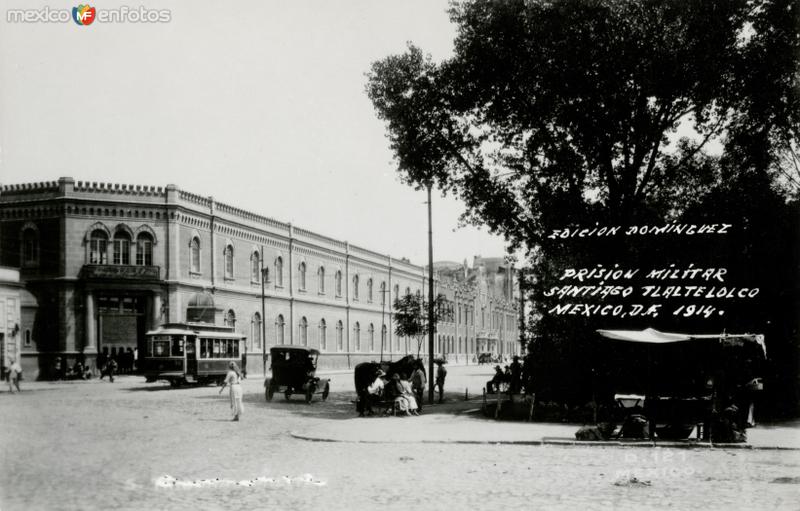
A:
367,0,800,416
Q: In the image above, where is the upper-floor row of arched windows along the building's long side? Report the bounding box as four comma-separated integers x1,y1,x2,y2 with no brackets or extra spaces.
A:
189,236,419,305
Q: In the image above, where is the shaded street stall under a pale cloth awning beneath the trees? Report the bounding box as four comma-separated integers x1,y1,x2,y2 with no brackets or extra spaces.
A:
595,328,766,442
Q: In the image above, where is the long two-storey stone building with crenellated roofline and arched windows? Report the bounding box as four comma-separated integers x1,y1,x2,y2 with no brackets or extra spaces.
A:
0,178,520,378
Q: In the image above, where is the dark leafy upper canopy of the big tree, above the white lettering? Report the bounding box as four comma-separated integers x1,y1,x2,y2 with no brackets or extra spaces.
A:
367,0,800,254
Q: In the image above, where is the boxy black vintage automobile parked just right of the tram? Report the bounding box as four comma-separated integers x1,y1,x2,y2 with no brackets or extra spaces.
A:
264,345,331,403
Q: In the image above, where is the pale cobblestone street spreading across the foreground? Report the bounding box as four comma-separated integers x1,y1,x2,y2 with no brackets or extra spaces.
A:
0,366,800,511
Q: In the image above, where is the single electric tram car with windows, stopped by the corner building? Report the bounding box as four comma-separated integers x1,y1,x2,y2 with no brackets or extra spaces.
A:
140,323,245,387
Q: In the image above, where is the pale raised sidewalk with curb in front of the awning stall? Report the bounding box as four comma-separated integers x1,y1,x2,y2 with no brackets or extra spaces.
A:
291,410,800,450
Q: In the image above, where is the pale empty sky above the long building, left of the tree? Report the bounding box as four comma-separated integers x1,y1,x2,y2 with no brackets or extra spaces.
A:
0,0,504,264
